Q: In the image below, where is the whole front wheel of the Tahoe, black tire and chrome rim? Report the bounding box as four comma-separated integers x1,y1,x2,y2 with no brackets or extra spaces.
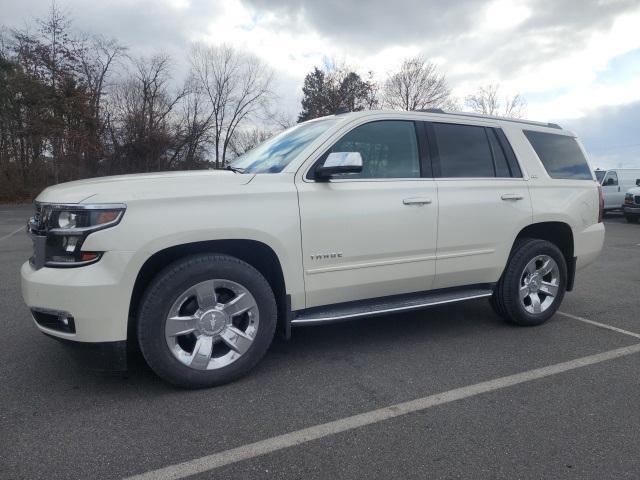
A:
138,254,277,388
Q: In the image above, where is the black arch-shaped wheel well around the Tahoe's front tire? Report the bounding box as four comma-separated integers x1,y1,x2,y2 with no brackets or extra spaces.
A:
127,239,291,339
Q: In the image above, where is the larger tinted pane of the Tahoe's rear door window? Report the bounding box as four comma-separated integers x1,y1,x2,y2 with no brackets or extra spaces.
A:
433,123,496,178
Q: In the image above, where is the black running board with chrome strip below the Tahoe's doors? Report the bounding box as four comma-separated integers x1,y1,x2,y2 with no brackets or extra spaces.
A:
291,284,493,325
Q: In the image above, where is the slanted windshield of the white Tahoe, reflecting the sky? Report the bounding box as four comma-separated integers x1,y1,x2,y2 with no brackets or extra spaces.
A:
230,117,342,173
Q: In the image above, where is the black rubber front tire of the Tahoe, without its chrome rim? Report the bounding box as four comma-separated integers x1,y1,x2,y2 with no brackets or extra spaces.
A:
138,254,277,388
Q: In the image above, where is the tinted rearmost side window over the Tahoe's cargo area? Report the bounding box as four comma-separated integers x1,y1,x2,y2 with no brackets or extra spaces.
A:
523,130,593,180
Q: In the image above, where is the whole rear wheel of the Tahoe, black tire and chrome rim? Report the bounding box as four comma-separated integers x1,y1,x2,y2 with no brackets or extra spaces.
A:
491,239,567,326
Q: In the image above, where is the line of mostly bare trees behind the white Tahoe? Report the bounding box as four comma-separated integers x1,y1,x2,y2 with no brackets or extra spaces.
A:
0,4,525,201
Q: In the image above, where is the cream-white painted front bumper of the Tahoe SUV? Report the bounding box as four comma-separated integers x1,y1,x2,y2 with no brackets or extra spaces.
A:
20,252,135,343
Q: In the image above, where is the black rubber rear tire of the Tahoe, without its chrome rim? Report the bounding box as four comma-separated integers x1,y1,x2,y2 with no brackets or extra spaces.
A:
491,238,567,326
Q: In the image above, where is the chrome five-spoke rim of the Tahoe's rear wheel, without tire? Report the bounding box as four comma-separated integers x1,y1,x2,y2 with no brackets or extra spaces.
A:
519,255,560,314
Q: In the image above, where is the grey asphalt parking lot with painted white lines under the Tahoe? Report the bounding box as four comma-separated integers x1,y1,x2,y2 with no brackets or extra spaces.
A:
0,205,640,479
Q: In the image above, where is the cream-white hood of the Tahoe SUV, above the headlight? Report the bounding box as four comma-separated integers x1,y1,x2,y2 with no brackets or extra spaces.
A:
36,170,254,203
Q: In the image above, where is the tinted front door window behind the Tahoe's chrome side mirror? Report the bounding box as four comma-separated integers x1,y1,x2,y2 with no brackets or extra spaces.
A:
325,120,420,178
